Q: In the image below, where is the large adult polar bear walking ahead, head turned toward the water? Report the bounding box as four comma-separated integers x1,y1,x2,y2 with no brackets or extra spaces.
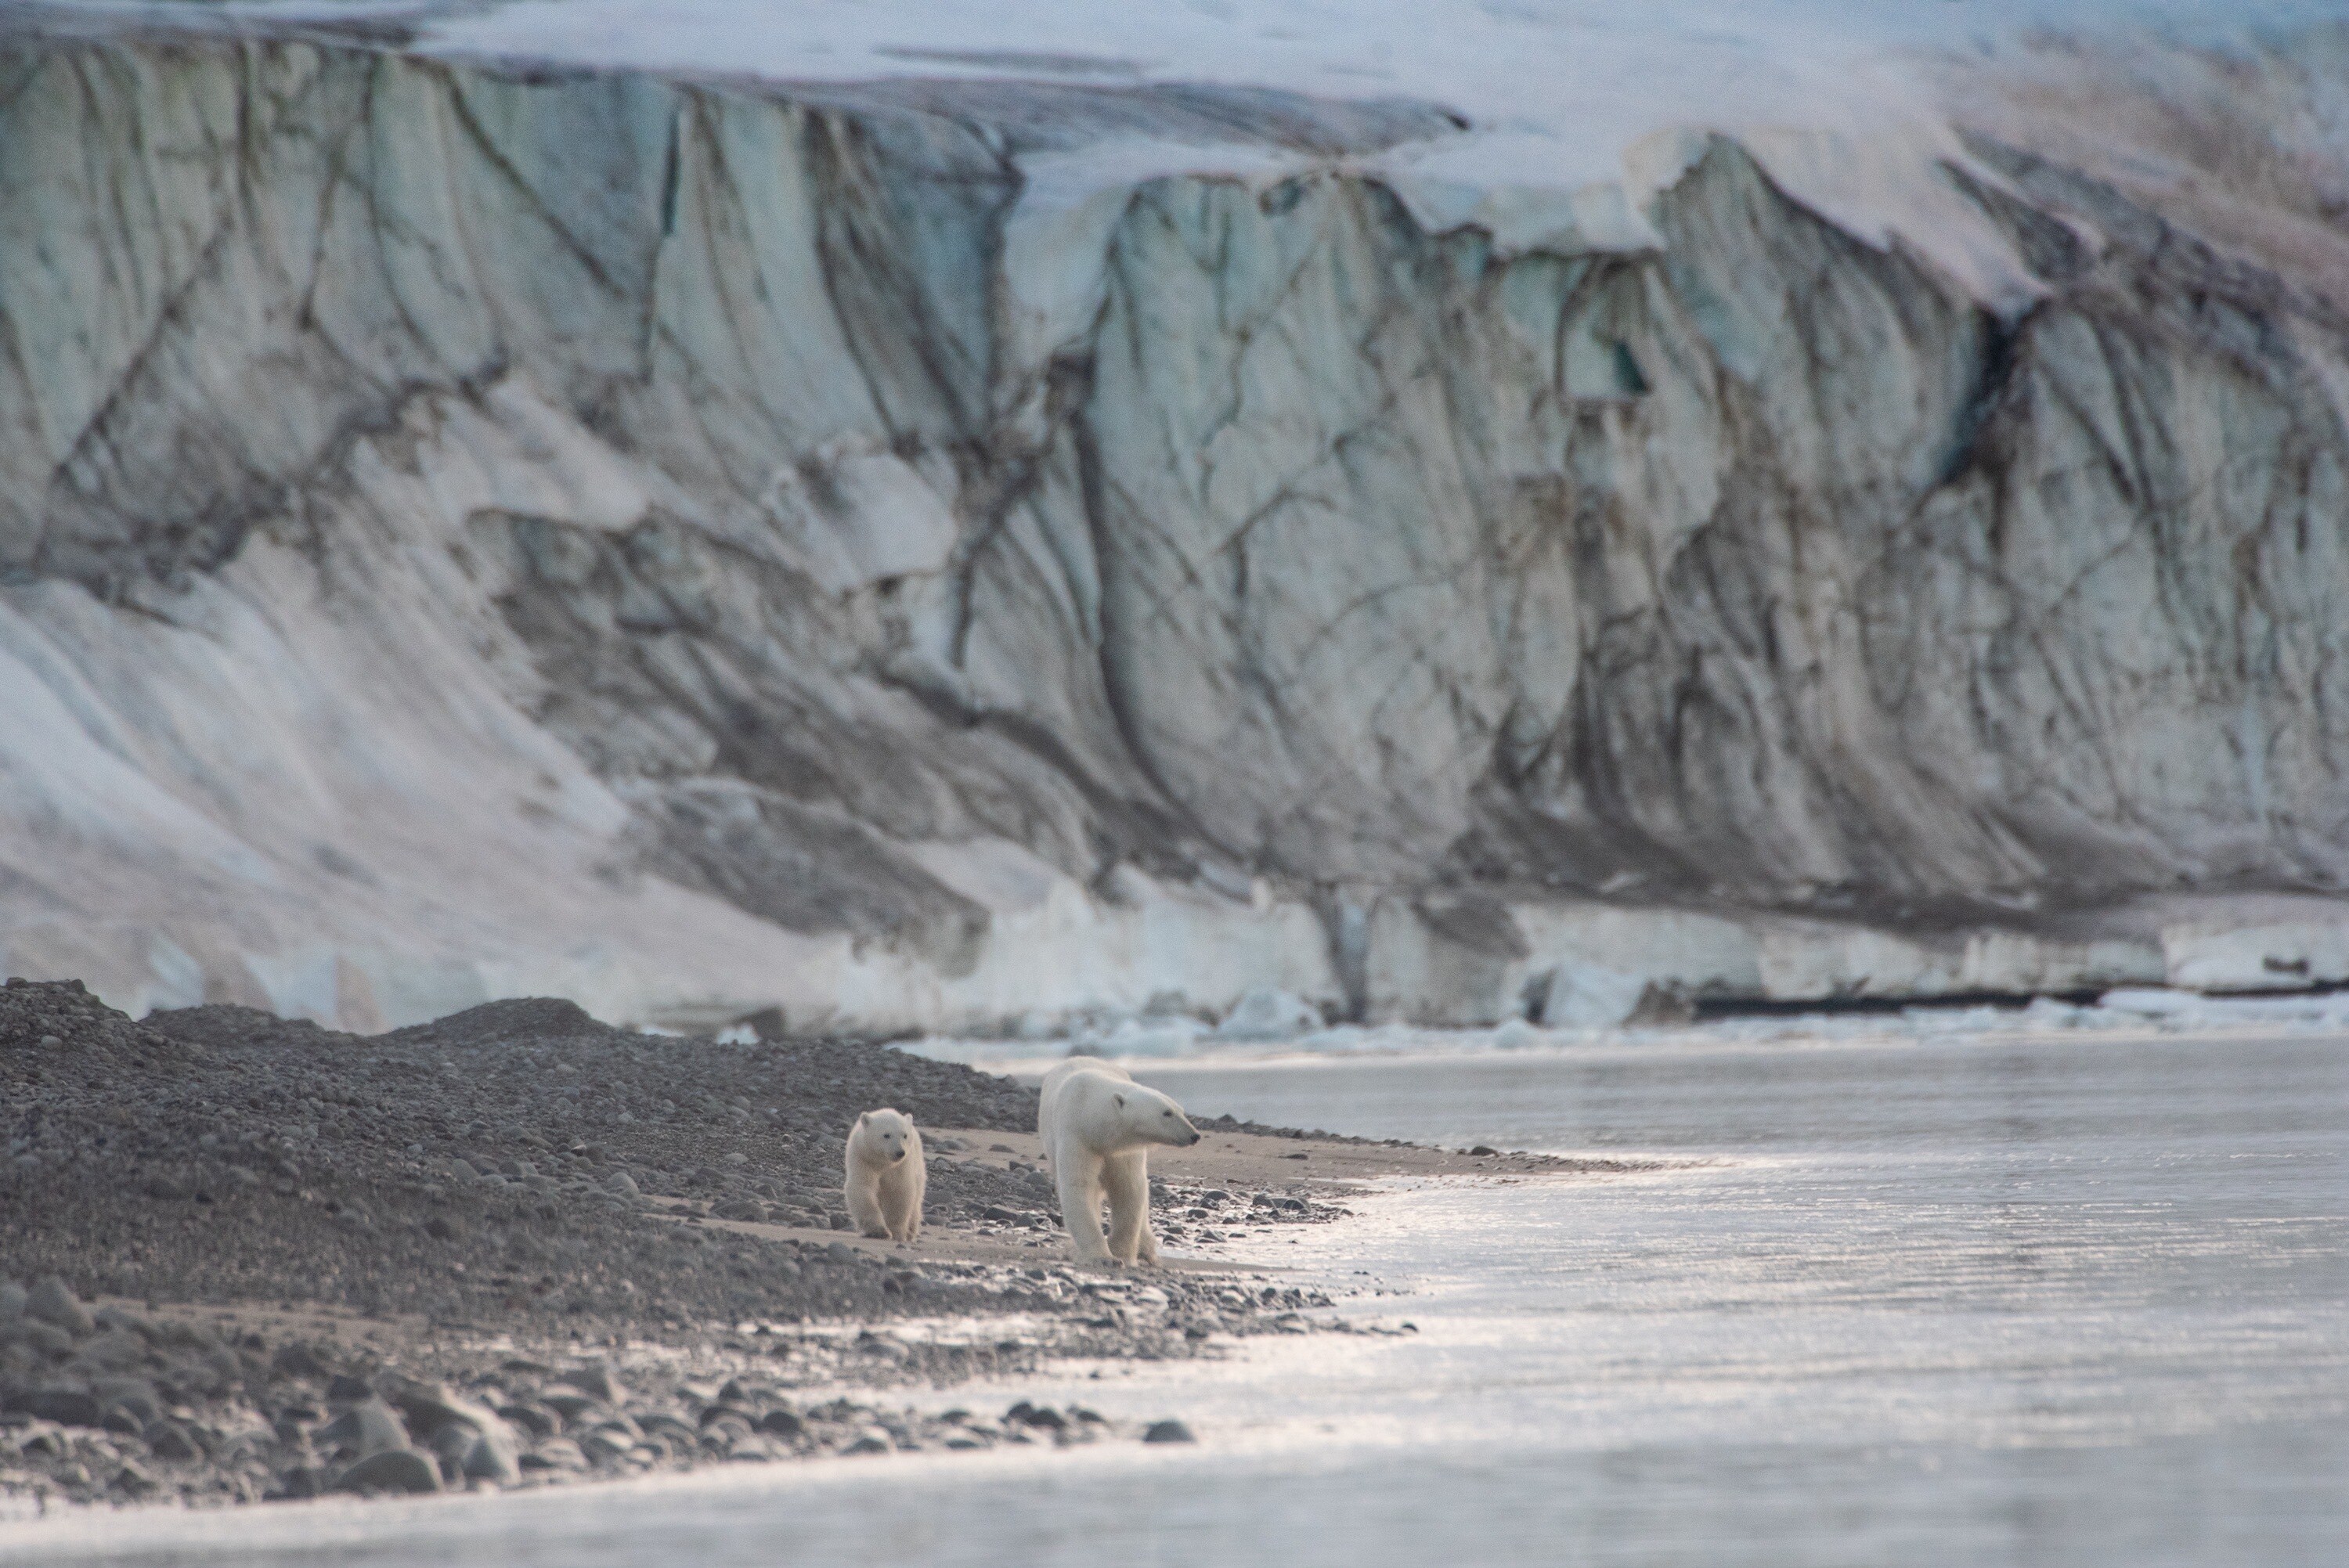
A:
1036,1056,1198,1263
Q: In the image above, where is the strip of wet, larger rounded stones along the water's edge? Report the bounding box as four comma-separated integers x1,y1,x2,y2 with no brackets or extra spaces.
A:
0,1270,1268,1516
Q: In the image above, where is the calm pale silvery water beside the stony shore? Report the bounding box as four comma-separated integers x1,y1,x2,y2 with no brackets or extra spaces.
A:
0,1030,2349,1568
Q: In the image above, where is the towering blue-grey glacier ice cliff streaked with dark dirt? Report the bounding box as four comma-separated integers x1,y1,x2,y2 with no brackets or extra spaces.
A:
0,14,2349,1026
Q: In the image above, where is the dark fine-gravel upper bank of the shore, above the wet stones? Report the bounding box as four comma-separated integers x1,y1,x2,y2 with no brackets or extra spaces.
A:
0,981,1050,1331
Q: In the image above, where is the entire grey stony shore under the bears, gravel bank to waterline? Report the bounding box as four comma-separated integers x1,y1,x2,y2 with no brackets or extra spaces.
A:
0,981,1555,1514
